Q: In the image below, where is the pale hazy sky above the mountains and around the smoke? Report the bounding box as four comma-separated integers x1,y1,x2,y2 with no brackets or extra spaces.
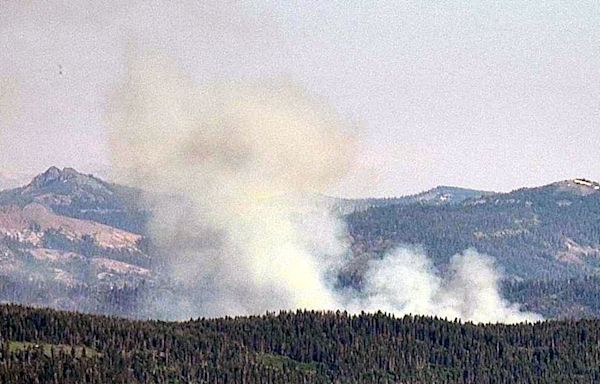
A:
0,0,600,196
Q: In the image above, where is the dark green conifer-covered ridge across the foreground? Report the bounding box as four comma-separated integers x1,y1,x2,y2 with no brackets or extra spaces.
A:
0,306,600,384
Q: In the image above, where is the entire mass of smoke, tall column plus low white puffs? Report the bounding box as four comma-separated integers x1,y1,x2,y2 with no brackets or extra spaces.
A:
109,52,532,322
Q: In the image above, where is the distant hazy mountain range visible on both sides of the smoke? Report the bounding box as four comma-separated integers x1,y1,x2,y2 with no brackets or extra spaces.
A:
0,167,600,317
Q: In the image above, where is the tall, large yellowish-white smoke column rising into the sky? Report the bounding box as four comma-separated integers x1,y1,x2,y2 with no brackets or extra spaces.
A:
111,53,352,315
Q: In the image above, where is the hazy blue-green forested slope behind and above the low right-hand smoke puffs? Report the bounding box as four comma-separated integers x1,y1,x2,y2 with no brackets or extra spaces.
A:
346,181,600,280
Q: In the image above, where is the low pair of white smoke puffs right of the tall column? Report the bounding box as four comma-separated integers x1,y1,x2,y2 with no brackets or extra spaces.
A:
349,248,542,323
